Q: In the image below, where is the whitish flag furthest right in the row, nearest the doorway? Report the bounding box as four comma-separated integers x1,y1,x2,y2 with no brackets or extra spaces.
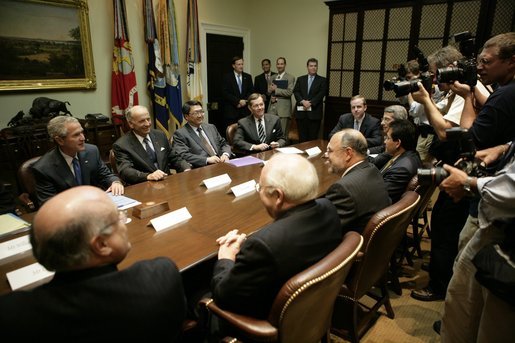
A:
186,0,202,101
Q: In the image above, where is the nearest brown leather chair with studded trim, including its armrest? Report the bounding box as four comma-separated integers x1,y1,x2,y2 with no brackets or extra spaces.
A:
201,232,363,343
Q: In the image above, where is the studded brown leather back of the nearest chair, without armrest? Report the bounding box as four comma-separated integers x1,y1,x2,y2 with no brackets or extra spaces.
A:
268,232,363,342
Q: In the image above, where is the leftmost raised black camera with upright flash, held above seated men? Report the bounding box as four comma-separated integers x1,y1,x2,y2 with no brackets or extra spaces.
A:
383,46,433,98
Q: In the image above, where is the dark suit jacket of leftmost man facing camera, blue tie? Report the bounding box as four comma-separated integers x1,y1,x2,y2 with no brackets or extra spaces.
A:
32,144,120,205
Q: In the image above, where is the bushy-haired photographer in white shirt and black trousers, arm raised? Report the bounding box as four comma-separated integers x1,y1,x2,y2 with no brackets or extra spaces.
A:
411,46,488,301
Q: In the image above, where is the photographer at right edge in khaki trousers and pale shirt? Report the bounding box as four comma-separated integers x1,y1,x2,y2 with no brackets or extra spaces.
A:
440,144,515,343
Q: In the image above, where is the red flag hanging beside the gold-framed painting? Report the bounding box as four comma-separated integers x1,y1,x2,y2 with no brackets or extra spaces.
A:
111,0,138,132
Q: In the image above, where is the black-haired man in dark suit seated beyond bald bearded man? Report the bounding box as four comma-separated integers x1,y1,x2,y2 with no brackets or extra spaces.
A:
373,119,422,203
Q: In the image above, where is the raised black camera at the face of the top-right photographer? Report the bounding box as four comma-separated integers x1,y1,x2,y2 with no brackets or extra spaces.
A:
436,31,477,87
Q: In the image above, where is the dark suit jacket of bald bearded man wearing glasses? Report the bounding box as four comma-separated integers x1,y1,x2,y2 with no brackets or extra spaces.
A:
325,161,390,234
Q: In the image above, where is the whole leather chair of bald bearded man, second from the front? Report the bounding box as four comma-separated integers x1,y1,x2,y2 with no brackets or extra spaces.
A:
331,191,420,342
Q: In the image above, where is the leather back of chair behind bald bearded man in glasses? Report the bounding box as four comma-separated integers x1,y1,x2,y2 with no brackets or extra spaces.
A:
346,191,420,299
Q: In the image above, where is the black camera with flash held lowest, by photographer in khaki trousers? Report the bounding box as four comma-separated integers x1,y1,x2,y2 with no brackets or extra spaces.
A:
417,127,490,185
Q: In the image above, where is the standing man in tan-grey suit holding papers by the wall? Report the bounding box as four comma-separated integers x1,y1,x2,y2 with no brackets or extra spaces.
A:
268,57,295,138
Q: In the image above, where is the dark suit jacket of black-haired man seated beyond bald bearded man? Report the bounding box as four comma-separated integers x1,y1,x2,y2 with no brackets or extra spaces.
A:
374,151,422,203
